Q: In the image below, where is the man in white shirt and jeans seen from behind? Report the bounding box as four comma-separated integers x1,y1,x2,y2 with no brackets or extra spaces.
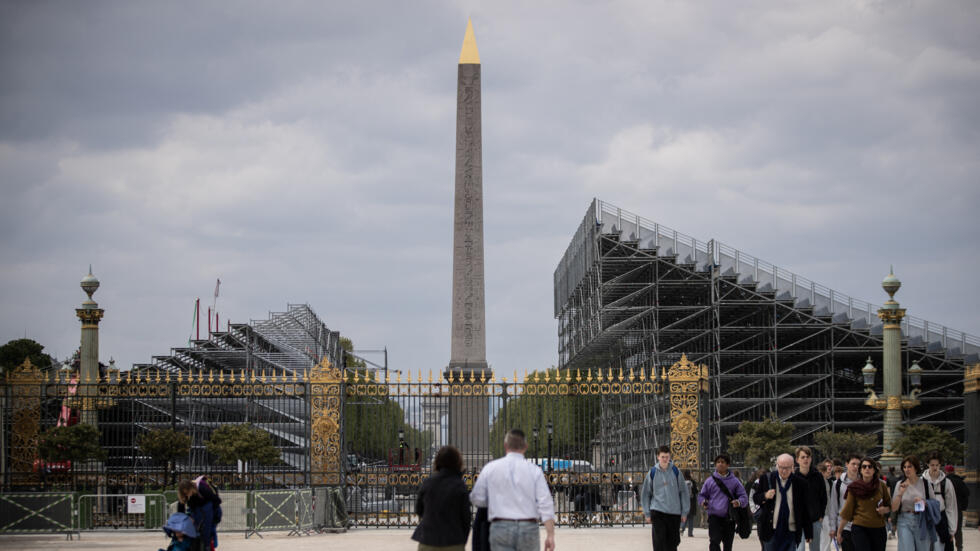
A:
470,429,555,551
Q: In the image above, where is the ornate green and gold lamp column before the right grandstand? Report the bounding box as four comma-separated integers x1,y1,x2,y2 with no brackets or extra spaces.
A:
861,273,922,466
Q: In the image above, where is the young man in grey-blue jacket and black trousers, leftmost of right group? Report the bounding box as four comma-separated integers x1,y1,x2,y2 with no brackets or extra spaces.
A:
640,446,691,551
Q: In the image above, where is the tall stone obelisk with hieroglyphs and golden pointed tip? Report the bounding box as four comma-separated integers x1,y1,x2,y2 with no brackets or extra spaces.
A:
445,21,490,468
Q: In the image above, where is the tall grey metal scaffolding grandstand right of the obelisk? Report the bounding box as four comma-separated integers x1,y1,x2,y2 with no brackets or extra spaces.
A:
554,200,980,468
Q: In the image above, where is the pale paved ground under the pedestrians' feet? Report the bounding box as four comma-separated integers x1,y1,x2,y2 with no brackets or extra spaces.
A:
0,528,980,551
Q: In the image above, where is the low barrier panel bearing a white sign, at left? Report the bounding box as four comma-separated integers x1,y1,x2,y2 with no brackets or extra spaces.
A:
77,494,170,530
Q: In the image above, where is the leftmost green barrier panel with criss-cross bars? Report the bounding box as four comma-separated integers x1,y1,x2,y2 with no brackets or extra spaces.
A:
0,493,75,534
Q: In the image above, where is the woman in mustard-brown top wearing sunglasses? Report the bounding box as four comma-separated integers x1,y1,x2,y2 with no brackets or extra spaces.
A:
837,457,892,551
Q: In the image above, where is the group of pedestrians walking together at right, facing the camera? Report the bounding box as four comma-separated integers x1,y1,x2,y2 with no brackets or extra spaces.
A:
640,446,969,551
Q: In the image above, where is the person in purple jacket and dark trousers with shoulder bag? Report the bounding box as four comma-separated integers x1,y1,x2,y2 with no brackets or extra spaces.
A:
698,453,749,551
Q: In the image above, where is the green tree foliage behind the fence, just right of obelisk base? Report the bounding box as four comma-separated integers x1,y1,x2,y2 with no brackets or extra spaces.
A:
490,368,600,461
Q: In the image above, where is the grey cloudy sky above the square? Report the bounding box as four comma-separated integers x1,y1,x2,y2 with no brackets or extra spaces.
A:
0,0,980,374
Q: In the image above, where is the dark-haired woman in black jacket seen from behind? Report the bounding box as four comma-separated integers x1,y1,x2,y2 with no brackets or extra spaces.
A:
412,446,471,551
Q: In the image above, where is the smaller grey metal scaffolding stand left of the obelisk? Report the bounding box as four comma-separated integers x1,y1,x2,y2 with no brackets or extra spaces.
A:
119,304,343,471
